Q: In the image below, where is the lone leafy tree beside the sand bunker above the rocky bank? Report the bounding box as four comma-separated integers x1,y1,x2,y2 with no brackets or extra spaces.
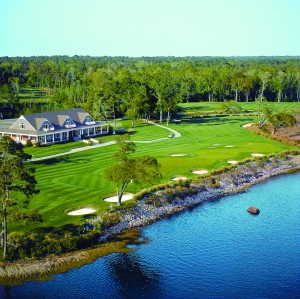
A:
104,135,161,205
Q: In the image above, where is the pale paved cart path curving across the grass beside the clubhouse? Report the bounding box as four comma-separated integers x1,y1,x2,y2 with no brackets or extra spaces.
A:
30,121,181,162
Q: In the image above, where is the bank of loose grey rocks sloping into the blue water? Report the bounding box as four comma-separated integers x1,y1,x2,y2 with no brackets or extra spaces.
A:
99,155,300,242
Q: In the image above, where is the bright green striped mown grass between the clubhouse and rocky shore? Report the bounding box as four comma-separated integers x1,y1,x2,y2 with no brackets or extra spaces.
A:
15,116,298,231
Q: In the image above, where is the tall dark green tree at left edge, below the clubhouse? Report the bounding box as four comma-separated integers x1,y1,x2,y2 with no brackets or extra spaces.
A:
0,136,38,259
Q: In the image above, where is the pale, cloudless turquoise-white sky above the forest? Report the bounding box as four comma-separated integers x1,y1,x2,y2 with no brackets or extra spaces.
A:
0,0,300,57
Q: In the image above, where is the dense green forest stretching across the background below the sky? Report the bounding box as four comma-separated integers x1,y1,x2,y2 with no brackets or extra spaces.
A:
0,56,300,120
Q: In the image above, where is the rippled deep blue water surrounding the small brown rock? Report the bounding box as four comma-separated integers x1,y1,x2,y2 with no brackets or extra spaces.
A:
0,173,300,298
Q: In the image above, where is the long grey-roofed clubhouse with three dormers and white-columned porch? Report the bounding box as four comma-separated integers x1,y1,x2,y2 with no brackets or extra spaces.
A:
0,108,109,144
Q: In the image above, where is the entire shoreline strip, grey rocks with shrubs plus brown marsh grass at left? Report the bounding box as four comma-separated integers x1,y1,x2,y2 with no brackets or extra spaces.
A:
0,152,300,284
